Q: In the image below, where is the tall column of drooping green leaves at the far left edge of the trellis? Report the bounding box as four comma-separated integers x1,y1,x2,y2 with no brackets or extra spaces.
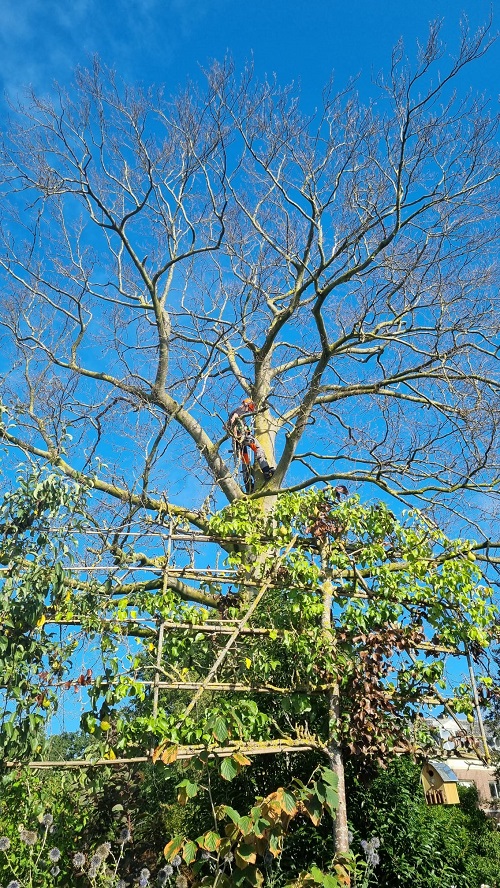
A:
0,470,91,761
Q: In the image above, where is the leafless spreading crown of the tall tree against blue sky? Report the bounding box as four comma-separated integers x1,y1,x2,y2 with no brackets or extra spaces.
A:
0,25,499,548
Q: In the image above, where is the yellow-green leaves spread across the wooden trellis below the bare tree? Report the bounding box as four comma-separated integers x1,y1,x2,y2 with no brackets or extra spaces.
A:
0,472,496,776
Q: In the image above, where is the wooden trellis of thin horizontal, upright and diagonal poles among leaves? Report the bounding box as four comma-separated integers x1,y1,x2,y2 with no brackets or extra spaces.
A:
0,528,488,769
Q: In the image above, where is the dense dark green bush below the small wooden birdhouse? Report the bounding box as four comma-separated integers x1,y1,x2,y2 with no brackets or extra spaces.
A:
348,757,500,888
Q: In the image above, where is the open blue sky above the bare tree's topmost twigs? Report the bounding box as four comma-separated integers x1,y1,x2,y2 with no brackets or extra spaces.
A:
0,0,500,109
